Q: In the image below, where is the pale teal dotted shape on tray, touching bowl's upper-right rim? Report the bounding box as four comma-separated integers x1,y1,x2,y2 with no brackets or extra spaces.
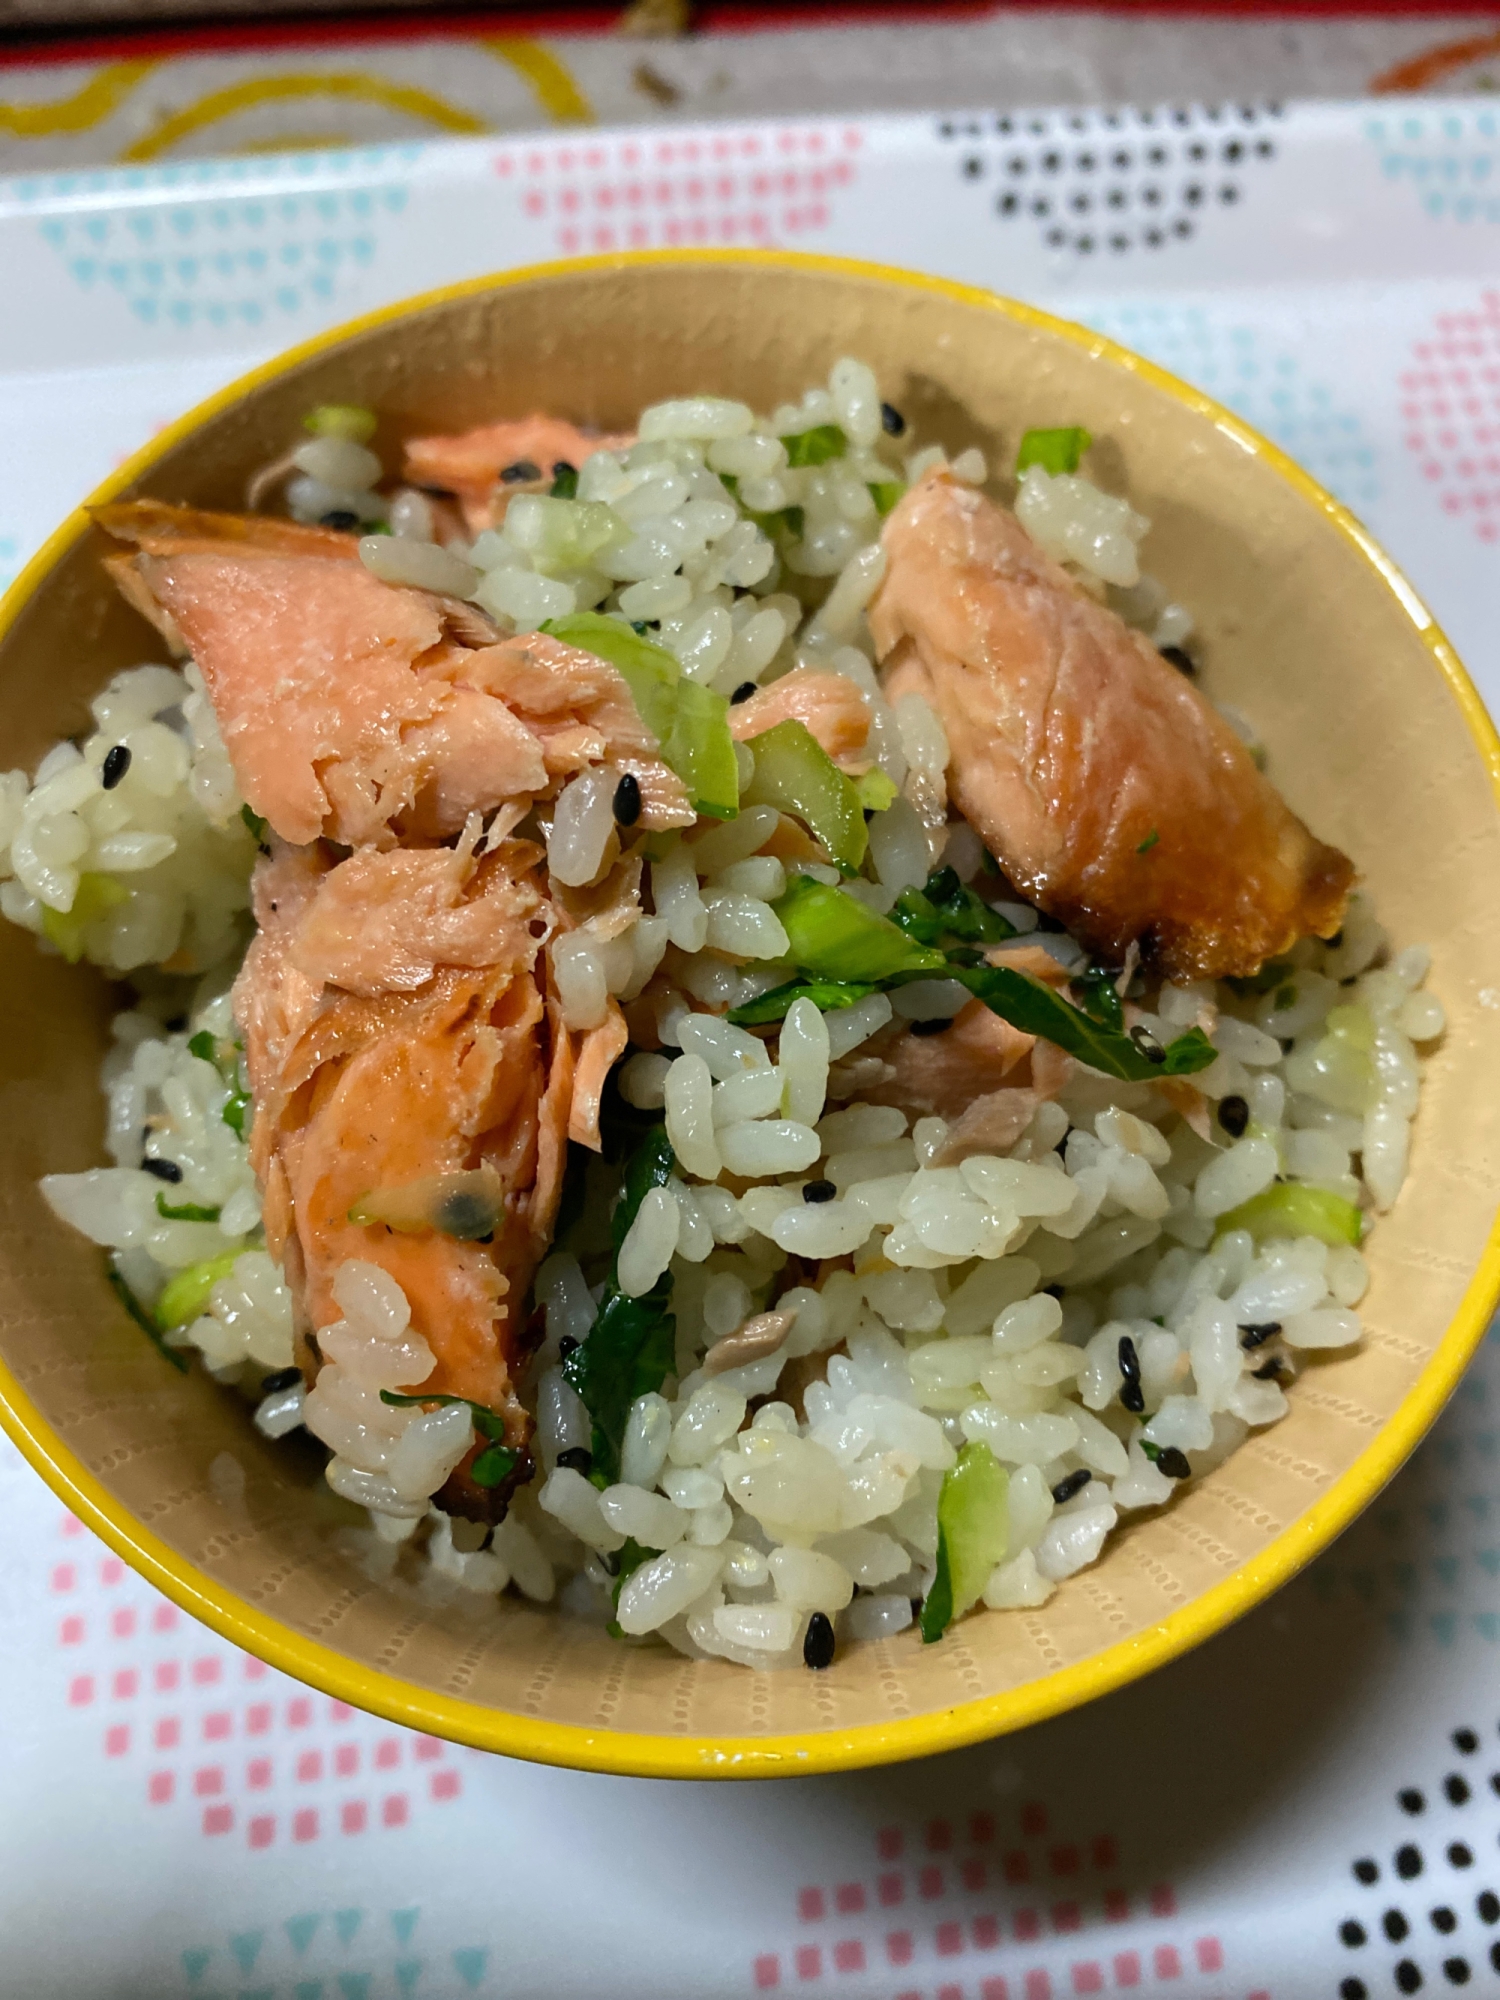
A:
1084,302,1382,510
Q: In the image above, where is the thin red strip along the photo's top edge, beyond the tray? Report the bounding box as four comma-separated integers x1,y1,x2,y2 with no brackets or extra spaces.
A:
0,0,1480,68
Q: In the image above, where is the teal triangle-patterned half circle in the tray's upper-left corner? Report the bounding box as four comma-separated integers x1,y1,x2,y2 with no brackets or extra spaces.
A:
14,146,422,334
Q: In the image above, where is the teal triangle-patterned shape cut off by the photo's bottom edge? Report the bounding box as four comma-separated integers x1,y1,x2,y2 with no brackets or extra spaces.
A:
176,1908,490,2000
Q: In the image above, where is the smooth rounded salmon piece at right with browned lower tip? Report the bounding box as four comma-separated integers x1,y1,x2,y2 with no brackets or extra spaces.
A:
870,470,1354,980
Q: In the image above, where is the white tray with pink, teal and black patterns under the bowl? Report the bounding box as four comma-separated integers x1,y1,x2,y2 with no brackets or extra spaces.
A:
0,98,1500,2000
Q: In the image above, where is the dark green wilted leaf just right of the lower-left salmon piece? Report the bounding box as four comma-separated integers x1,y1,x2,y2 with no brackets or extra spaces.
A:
562,1124,676,1484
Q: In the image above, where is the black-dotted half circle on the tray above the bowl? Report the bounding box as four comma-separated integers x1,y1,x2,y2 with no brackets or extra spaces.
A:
938,104,1282,262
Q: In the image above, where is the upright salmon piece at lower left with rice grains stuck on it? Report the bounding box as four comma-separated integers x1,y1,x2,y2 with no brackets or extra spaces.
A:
234,840,574,1446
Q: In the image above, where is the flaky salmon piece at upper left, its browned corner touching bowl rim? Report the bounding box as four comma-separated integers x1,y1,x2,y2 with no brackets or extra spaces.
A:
94,500,694,846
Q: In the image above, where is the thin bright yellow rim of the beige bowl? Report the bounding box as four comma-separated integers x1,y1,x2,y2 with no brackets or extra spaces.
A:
0,250,1500,1778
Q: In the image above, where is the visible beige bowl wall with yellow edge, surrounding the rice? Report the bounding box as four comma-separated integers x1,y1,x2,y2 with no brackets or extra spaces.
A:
0,256,1500,1774
